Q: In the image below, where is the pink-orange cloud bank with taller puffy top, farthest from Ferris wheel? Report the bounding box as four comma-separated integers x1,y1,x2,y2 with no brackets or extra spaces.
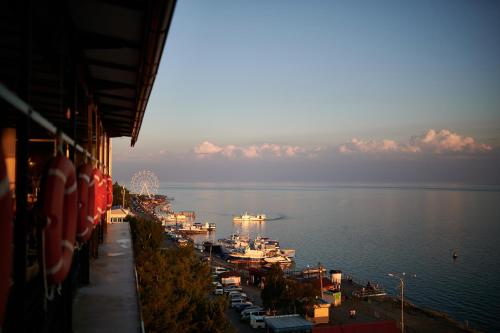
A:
338,129,492,154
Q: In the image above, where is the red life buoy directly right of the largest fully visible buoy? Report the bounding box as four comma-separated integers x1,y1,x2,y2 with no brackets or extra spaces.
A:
76,164,95,242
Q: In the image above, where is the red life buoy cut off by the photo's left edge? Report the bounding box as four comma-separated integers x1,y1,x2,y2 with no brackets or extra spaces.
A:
0,147,12,327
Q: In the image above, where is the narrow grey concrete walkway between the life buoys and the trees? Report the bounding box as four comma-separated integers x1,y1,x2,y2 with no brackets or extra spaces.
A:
73,223,141,333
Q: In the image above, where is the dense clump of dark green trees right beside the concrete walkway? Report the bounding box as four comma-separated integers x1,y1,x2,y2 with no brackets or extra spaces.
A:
128,217,230,333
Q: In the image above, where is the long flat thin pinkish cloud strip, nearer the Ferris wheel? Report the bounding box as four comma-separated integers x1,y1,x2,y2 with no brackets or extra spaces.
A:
193,141,322,159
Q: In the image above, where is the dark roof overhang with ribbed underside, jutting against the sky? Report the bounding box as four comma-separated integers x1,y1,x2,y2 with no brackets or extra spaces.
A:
68,0,175,146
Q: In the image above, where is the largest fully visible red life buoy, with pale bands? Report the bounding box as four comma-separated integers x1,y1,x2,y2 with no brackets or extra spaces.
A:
42,155,78,283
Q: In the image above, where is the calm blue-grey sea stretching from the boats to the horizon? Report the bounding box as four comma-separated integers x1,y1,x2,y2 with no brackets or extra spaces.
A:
161,184,500,332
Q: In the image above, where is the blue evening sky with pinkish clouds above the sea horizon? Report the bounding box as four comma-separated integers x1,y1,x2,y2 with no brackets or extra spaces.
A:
113,0,500,184
